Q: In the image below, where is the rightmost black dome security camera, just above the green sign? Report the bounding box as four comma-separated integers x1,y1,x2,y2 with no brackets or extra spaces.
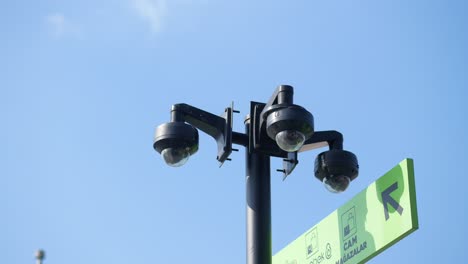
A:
314,149,359,193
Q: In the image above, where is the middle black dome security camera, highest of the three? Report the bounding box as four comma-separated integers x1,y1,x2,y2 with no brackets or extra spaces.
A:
266,105,314,152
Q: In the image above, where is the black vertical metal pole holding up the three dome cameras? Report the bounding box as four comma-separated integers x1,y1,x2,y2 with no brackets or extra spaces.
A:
245,119,272,264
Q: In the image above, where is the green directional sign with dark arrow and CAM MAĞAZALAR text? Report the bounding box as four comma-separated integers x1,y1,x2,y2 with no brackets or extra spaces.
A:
273,159,418,264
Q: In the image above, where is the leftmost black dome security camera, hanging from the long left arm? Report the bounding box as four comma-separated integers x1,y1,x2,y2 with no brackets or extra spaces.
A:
153,122,198,167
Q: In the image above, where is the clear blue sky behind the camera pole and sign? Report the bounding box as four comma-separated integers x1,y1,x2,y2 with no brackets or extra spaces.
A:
0,0,468,264
